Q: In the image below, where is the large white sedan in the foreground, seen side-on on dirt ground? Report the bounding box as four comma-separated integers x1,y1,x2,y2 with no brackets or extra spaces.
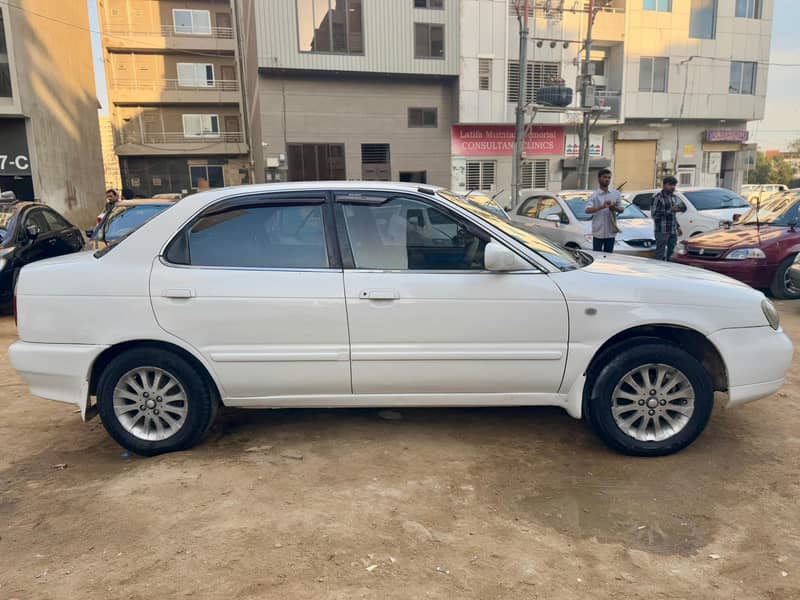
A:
9,182,792,456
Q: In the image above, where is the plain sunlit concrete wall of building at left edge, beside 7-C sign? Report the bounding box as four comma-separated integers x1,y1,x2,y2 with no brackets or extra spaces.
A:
0,0,105,224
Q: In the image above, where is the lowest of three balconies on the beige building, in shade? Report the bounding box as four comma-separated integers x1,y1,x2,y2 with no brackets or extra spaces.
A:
115,131,248,156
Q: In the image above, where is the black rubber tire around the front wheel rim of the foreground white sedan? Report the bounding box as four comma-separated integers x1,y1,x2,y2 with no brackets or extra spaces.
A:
585,338,714,456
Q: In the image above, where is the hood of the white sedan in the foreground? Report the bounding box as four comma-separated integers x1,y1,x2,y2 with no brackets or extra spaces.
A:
552,253,764,312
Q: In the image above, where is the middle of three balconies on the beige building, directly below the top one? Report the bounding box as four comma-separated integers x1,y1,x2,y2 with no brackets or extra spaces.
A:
108,79,242,104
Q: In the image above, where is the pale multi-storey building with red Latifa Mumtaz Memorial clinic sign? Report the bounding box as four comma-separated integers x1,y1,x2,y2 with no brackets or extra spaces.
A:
460,0,773,199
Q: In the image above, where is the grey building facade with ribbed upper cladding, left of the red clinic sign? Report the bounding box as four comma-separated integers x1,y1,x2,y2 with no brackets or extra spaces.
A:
256,0,460,185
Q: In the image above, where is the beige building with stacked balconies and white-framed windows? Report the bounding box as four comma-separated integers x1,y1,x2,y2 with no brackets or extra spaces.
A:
98,0,263,196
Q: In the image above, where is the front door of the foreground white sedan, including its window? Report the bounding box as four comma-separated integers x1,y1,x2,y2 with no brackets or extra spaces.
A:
335,192,568,396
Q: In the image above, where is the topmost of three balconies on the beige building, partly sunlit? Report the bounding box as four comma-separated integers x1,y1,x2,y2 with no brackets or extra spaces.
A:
103,25,236,52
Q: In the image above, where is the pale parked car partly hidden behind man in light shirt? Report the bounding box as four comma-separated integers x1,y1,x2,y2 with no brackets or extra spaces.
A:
511,190,656,256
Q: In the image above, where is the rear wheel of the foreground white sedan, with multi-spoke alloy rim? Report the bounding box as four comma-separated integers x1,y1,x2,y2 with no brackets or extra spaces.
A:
97,348,217,456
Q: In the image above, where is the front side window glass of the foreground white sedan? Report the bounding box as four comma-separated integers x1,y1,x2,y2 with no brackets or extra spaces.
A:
337,194,486,271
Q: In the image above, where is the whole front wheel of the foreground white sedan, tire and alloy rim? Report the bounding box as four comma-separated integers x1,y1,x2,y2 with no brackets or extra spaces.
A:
586,339,714,456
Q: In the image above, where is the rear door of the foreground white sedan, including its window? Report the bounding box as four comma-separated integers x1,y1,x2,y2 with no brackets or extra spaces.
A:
150,192,351,406
